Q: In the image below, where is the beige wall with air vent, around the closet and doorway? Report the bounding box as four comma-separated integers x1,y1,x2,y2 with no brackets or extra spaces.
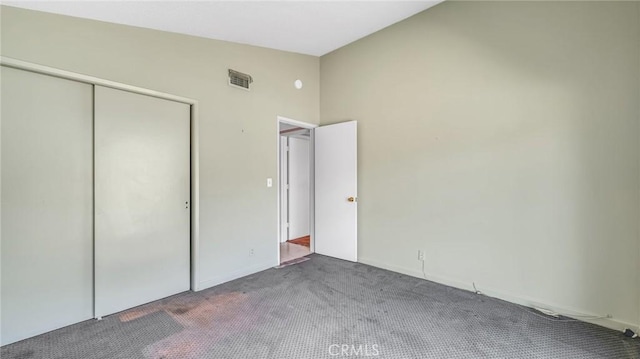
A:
1,6,319,287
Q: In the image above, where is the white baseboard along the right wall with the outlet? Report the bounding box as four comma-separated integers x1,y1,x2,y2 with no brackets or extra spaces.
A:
358,257,640,331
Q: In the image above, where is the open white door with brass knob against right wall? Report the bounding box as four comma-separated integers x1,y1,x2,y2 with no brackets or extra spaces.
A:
315,121,358,262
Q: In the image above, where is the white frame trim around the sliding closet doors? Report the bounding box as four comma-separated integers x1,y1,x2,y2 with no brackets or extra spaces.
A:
0,56,201,291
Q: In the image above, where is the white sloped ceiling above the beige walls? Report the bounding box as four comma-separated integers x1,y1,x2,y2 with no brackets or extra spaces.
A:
2,0,443,56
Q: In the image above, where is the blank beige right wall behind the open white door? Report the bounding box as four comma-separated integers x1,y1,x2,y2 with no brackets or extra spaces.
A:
320,2,640,327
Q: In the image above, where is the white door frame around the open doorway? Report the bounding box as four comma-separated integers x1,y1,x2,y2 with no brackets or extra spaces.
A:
276,116,318,266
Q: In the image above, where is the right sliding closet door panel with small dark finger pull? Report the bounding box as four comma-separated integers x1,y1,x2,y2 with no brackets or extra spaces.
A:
95,86,190,317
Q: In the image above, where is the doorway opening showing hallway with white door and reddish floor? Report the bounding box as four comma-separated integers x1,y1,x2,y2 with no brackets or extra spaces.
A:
278,117,315,264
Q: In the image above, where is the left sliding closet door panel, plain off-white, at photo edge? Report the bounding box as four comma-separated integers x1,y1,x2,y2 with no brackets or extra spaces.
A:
0,67,93,345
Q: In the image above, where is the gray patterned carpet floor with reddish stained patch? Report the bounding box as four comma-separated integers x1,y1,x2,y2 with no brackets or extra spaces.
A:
0,255,640,359
